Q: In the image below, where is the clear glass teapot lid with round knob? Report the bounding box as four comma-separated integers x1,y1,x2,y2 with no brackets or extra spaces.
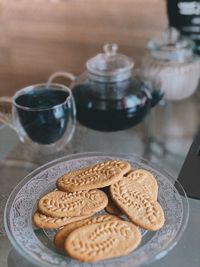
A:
86,43,134,82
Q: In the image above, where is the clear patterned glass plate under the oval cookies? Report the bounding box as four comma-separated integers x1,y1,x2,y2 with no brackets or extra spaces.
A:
4,153,189,267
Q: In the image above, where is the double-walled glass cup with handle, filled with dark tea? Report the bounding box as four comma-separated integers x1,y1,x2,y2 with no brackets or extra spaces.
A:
0,83,76,152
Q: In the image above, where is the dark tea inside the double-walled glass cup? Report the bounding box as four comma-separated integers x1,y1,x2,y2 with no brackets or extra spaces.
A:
15,88,69,145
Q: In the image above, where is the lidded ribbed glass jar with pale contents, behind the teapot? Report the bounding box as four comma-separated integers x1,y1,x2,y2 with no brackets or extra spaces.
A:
141,28,200,100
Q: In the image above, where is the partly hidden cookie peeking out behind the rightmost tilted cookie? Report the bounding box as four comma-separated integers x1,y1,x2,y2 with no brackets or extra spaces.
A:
126,169,158,200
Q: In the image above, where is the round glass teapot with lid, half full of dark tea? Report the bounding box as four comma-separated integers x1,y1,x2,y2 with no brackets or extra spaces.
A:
50,44,162,131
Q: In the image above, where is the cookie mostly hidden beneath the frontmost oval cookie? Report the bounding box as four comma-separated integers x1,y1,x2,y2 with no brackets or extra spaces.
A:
54,214,119,250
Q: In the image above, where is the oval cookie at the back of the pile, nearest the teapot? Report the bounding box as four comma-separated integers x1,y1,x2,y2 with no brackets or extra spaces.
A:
56,160,131,192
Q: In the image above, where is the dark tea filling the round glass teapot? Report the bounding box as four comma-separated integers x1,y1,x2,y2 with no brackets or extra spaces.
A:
72,81,150,131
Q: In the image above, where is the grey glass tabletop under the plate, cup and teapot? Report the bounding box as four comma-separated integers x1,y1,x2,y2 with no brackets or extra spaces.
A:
0,92,200,267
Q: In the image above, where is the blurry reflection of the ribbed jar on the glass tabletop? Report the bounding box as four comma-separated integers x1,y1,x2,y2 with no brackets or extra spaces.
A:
150,100,199,157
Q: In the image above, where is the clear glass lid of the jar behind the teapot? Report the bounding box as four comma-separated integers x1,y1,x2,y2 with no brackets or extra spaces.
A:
148,27,194,62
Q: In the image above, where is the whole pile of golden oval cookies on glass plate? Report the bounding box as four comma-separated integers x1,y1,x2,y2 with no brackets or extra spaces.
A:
33,160,164,262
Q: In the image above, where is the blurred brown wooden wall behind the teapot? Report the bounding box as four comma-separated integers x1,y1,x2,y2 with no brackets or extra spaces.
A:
0,0,167,96
